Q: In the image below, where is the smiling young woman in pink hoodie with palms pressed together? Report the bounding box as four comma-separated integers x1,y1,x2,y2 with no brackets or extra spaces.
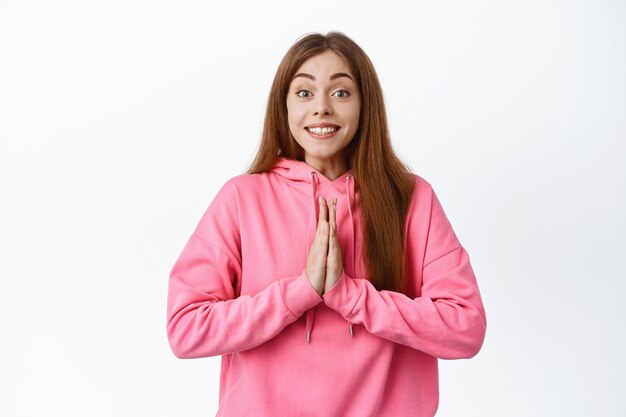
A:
167,32,486,417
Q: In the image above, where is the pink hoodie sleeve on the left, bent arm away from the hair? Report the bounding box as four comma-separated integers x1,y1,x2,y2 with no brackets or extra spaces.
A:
167,183,322,358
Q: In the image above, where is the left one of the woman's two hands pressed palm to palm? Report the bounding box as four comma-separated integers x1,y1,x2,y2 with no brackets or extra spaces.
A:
304,197,330,296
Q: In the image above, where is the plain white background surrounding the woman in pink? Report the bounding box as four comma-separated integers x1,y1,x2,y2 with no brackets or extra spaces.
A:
0,0,626,417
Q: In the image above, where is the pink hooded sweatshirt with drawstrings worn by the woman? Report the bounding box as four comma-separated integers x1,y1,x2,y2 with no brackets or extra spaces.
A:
167,158,486,417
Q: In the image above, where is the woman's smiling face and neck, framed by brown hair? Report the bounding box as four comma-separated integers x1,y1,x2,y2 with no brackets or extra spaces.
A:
287,51,361,169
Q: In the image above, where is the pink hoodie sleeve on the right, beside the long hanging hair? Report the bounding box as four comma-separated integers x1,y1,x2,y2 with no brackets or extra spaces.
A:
323,184,486,359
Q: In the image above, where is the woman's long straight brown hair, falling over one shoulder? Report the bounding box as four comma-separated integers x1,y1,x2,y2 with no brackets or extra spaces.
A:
247,32,415,291
